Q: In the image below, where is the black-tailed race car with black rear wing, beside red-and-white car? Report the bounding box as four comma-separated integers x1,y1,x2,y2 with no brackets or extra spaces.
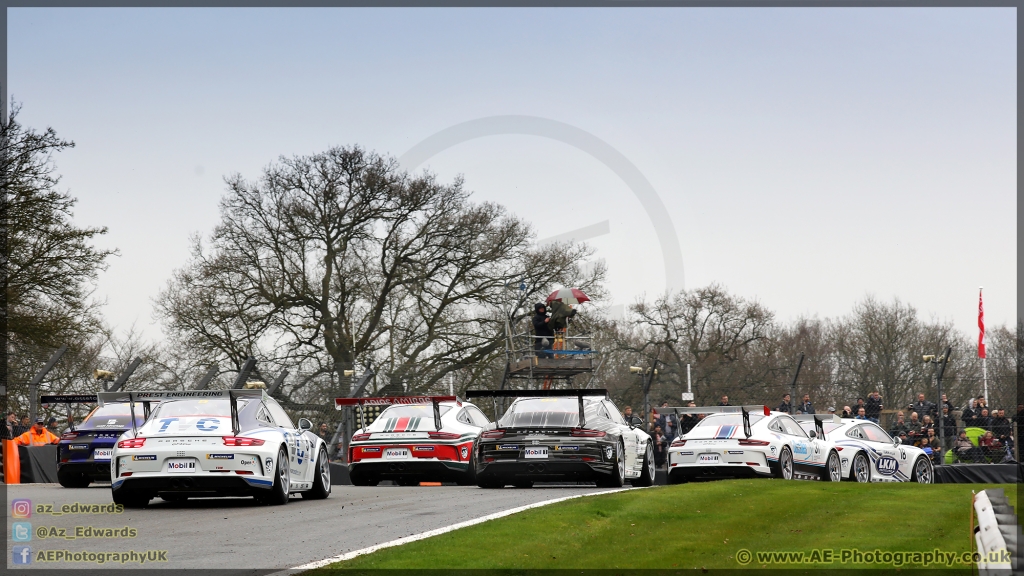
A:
466,389,654,488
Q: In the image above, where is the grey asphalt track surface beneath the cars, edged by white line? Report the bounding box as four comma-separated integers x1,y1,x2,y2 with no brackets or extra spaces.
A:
5,484,607,576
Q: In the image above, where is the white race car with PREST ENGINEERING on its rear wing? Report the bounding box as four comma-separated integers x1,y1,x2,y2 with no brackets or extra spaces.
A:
96,389,331,507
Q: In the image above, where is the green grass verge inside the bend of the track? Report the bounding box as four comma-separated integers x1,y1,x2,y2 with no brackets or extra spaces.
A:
315,480,1017,573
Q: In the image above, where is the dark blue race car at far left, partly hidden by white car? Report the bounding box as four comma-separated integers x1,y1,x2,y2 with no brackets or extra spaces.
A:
40,395,148,488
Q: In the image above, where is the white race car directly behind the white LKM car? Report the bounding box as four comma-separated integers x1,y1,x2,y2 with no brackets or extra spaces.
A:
658,406,842,484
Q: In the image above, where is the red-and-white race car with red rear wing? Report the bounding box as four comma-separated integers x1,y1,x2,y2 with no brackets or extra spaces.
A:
335,396,488,486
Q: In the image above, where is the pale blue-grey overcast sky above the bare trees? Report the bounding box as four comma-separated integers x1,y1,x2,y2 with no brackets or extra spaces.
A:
7,8,1017,339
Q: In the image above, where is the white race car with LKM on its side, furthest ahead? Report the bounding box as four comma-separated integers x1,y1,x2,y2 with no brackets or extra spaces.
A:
798,416,935,484
